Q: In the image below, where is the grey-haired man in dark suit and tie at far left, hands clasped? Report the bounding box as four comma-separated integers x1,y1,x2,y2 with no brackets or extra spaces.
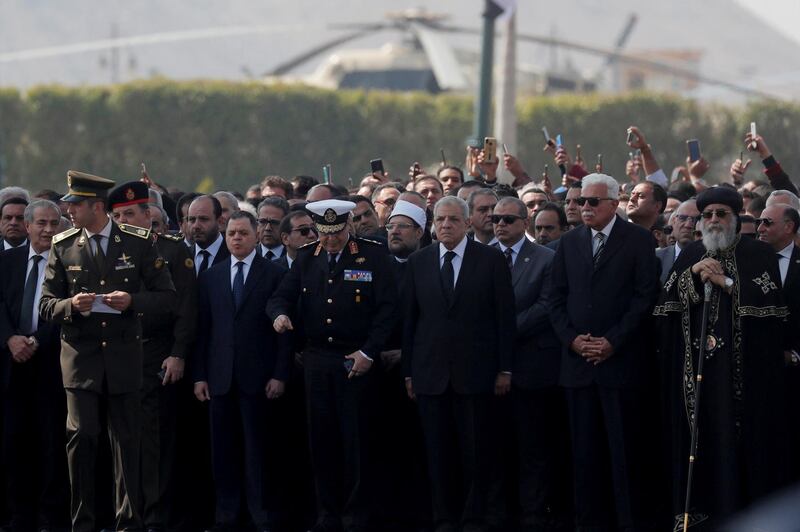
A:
0,200,69,530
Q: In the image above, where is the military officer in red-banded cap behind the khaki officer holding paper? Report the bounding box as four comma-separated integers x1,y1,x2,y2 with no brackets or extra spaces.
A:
108,181,197,532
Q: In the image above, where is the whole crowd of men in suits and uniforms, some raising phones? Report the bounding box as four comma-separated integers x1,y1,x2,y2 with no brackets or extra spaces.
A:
0,127,800,532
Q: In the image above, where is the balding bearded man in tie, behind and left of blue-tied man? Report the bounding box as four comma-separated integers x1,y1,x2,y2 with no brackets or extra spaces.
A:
186,196,231,275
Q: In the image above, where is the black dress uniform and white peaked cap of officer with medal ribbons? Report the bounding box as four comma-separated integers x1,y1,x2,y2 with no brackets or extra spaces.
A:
267,200,397,530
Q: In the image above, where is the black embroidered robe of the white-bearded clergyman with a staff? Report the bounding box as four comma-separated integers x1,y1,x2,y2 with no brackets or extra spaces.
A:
654,237,797,530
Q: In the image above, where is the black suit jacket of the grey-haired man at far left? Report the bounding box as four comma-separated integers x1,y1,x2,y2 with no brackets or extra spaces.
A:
0,245,61,390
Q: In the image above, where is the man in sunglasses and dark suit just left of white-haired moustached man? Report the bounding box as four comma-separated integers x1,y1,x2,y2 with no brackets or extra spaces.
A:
492,198,571,531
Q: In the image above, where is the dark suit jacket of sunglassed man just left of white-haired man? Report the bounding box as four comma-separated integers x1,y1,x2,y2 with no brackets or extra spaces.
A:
511,238,561,389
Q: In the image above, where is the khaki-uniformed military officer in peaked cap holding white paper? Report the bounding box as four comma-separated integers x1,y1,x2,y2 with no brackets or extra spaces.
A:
39,171,176,532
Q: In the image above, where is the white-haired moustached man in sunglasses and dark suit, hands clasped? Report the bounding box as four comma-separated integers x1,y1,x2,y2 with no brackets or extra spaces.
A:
551,174,658,530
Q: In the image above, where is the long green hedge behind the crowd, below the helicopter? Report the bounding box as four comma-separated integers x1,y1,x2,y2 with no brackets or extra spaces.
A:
0,80,800,190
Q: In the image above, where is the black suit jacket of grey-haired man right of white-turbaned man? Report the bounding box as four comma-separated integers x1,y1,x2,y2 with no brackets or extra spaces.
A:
403,240,516,395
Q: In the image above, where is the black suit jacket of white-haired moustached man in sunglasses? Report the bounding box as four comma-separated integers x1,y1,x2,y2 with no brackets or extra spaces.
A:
551,216,659,388
